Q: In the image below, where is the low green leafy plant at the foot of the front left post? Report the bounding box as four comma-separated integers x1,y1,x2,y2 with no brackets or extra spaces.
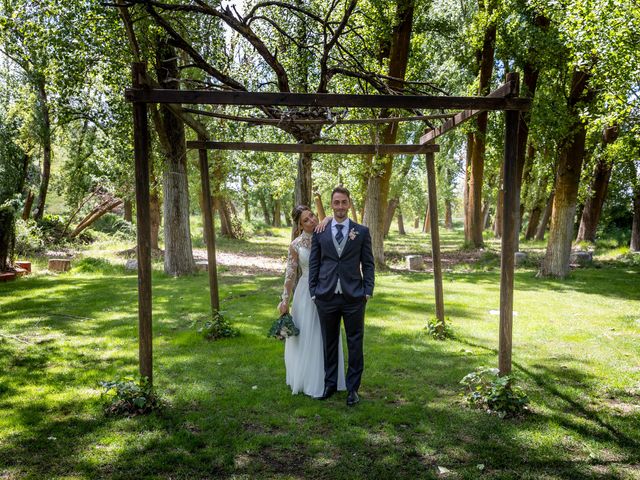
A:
99,377,164,417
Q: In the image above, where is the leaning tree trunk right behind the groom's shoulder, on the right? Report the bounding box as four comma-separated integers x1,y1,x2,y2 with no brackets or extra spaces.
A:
362,0,415,268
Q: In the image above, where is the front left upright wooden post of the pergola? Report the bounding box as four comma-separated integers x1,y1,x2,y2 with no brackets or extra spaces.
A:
131,63,153,382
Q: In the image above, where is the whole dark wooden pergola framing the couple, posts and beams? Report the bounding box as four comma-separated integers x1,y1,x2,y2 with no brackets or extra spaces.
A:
126,63,531,381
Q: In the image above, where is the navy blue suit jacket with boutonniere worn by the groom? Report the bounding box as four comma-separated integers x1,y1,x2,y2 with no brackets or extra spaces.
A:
309,220,375,300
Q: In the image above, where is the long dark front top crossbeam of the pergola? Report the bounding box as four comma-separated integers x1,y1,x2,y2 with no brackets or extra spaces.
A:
125,88,531,110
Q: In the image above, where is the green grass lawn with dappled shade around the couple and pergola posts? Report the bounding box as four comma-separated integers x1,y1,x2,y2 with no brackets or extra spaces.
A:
0,229,640,480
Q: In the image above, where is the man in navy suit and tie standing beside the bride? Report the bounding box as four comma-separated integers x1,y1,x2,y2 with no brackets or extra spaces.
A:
309,187,375,406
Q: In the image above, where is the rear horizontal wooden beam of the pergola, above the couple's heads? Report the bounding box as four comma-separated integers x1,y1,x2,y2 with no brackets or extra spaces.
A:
187,141,439,154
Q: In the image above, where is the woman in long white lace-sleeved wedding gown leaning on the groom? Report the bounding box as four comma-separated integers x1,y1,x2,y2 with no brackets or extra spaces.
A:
278,205,346,397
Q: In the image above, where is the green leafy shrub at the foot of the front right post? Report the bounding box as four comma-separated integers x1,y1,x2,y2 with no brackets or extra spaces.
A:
460,367,529,418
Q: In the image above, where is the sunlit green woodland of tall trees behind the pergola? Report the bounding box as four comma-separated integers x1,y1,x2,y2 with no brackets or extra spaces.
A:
0,0,640,277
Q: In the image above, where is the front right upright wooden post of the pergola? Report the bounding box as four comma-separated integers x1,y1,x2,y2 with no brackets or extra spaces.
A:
498,73,520,375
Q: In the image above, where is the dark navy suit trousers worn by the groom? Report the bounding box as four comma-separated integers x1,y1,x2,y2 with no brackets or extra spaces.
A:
316,294,367,391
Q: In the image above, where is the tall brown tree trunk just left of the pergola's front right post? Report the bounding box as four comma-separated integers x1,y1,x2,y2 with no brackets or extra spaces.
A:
465,1,496,248
